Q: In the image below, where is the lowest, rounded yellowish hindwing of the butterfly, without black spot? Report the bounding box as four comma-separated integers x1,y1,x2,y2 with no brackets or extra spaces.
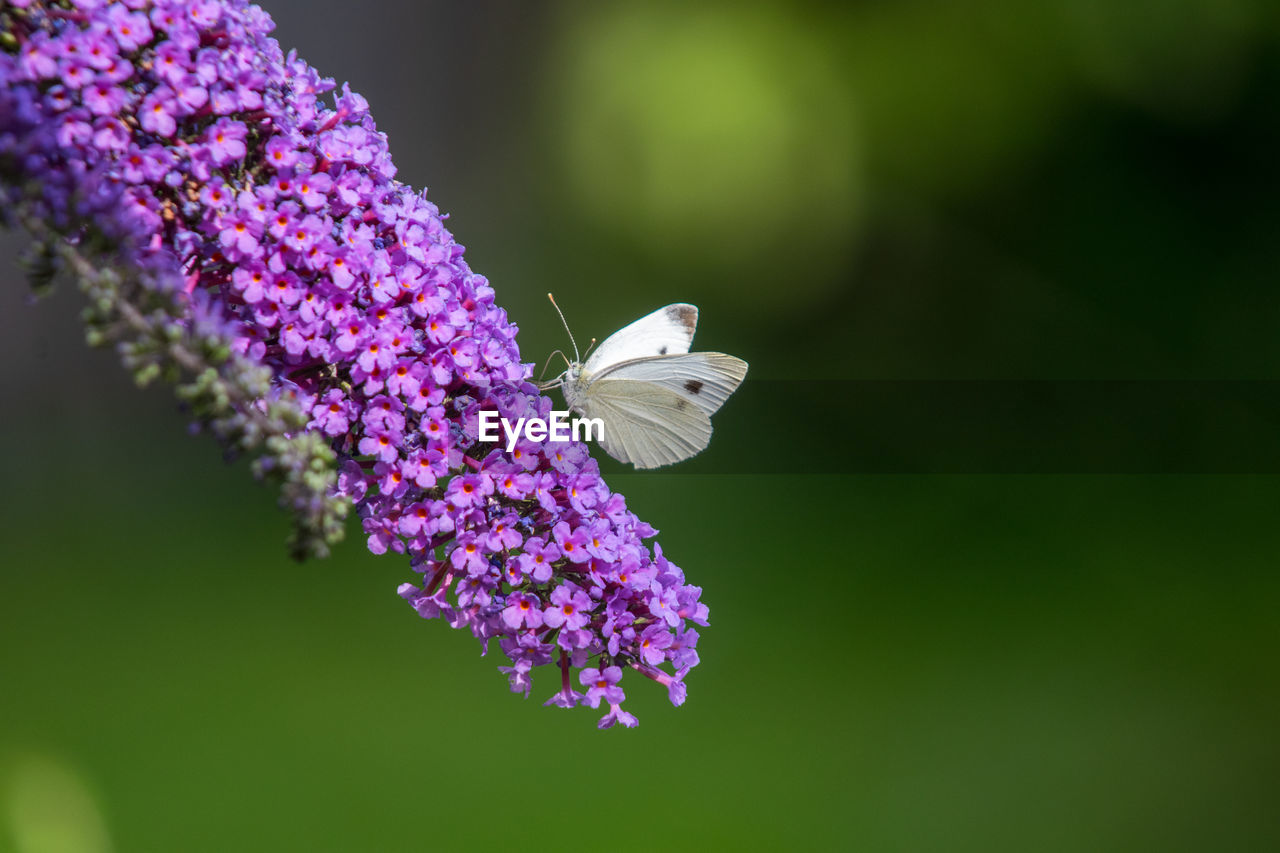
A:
576,379,712,469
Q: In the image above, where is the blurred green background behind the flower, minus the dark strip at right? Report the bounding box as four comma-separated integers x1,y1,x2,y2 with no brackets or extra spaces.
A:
0,0,1280,853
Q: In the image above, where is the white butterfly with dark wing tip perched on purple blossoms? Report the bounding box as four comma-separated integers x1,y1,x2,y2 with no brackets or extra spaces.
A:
544,293,746,469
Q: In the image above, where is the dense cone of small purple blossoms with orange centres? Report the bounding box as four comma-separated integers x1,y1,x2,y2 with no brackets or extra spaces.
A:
0,0,707,727
